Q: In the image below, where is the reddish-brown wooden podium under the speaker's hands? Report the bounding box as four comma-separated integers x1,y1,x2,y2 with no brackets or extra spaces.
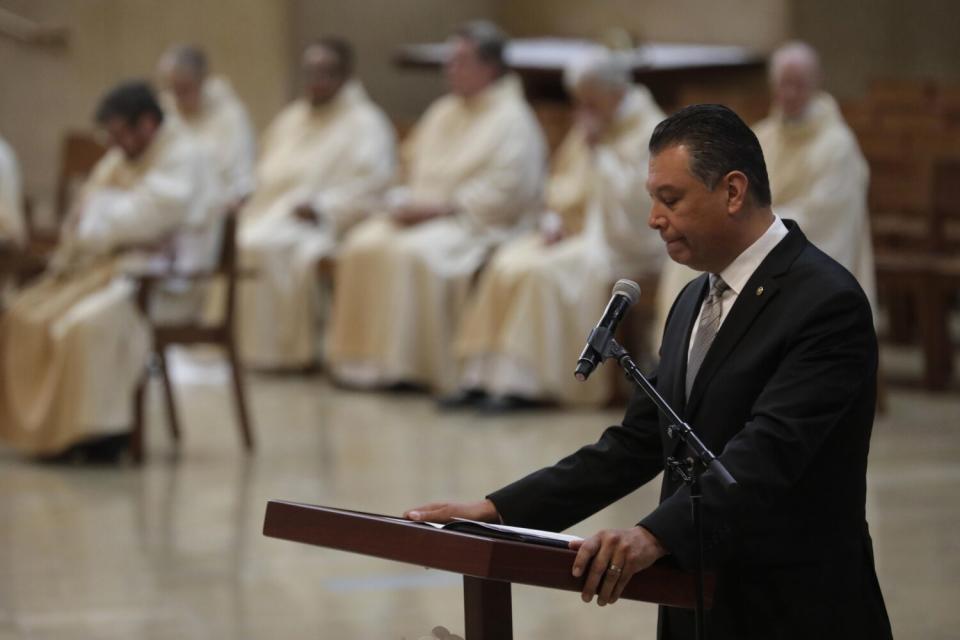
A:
263,500,713,640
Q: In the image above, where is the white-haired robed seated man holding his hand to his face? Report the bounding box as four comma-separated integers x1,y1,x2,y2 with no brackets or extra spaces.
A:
442,53,666,410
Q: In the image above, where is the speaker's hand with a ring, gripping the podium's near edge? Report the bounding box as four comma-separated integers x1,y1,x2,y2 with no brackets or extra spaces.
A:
570,526,667,607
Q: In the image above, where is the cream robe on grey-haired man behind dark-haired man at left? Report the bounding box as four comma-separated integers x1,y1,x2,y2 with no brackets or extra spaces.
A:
161,76,256,202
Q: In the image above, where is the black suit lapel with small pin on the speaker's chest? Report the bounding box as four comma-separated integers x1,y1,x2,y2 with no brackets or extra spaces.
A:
686,220,807,415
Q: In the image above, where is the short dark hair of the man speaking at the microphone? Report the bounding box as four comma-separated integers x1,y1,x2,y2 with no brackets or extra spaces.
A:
650,104,770,207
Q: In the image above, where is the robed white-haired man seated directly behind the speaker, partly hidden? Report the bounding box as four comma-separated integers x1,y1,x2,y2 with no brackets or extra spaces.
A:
656,42,876,344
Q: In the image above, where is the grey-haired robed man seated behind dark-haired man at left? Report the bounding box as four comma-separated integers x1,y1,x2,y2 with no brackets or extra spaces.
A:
158,45,255,203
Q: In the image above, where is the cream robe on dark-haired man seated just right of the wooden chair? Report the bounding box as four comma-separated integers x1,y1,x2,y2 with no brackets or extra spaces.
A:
239,82,396,368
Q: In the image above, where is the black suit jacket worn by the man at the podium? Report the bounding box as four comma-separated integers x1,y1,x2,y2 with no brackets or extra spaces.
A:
489,221,891,640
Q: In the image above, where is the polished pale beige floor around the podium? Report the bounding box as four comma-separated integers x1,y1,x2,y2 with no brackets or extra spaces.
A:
0,352,960,640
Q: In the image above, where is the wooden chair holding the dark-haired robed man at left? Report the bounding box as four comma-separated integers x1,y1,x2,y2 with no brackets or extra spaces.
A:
131,210,254,462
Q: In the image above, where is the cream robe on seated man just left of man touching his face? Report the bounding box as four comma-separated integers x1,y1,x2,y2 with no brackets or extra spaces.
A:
327,75,545,390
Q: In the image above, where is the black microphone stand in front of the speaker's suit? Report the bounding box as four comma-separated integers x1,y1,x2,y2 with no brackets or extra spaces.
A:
591,336,737,640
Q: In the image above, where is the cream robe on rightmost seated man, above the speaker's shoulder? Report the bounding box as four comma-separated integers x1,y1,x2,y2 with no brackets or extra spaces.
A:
755,93,876,309
